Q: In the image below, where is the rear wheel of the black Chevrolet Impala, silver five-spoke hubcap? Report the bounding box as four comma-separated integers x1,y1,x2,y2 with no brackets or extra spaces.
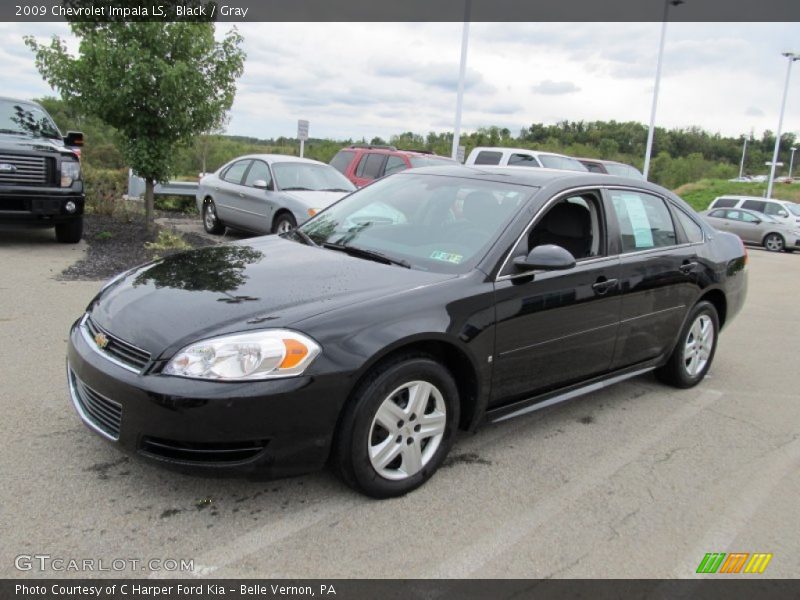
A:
656,301,719,388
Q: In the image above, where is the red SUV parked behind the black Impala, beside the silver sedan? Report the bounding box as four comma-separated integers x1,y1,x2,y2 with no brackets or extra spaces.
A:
330,144,456,187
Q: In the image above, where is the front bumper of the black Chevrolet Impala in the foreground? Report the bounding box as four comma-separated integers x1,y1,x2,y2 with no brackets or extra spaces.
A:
67,321,354,477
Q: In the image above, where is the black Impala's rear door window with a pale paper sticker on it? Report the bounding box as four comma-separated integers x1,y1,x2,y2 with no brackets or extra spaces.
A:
611,190,677,252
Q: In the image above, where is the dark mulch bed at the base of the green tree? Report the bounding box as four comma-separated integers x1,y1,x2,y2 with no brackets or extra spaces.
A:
59,213,215,281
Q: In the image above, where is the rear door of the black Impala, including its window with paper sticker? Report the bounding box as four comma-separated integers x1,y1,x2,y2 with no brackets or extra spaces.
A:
605,188,701,369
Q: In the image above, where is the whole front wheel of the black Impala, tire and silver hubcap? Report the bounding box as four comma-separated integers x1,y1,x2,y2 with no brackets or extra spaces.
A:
333,356,459,498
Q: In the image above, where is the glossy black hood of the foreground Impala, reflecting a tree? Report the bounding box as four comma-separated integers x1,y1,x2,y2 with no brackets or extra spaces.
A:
88,236,454,356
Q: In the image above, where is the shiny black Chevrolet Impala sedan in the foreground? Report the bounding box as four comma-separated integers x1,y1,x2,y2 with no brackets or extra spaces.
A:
67,166,747,497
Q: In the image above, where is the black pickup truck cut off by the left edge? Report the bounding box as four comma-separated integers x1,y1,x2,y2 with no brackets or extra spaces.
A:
0,97,85,244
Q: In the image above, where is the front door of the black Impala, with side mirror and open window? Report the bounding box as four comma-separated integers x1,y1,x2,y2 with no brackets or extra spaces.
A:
491,190,620,404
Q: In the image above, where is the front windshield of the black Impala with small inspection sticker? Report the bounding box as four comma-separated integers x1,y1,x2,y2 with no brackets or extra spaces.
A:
297,173,536,273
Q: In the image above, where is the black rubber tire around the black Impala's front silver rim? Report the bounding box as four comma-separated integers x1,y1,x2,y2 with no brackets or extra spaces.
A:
331,356,460,498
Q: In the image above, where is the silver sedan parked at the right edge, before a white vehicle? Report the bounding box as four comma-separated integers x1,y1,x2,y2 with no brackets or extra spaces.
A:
700,208,800,252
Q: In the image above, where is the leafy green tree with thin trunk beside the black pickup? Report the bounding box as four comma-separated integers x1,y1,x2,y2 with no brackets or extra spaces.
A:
25,15,245,228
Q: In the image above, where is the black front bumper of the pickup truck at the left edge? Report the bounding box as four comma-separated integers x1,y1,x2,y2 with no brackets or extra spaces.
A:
0,188,85,227
